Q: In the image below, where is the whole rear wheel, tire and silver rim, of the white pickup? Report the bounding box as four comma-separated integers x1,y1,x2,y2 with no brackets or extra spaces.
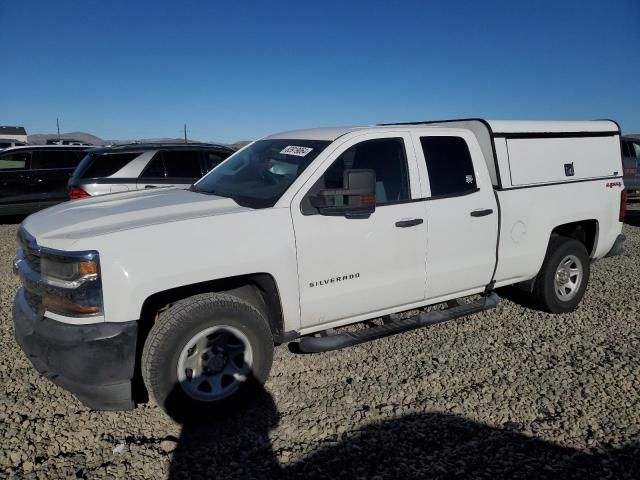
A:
533,236,590,313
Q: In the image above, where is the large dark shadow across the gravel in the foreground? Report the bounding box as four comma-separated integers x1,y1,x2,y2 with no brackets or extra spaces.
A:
169,382,640,480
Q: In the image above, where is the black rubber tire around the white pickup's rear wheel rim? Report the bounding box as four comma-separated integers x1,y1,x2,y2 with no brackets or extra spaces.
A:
533,235,591,313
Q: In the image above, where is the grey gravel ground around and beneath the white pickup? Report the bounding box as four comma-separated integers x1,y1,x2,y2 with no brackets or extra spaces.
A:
0,212,640,479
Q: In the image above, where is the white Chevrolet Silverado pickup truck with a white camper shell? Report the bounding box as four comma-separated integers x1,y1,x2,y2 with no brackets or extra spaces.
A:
13,119,624,412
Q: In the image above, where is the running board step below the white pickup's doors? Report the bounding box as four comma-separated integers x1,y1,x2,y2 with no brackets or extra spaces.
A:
298,292,500,353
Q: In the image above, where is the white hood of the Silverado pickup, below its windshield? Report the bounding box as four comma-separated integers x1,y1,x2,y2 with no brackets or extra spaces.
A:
23,188,251,250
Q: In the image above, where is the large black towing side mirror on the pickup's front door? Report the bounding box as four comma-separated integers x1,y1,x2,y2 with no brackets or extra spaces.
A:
310,169,376,218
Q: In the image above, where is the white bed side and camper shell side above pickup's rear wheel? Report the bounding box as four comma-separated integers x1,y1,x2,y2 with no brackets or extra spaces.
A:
494,122,624,286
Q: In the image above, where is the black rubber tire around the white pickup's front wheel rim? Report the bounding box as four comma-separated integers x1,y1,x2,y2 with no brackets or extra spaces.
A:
141,293,274,421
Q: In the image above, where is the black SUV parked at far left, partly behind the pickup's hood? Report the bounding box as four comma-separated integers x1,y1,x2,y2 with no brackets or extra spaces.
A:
0,145,87,215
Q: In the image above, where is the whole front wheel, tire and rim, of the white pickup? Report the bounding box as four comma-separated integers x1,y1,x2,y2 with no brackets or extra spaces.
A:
142,293,273,419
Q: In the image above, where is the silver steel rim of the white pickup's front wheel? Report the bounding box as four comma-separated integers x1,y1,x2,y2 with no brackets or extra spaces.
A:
177,325,253,402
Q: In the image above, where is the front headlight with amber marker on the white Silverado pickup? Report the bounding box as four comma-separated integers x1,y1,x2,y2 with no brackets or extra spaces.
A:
40,252,102,316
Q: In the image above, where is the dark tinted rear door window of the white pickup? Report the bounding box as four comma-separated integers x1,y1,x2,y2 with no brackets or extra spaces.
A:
420,136,478,197
